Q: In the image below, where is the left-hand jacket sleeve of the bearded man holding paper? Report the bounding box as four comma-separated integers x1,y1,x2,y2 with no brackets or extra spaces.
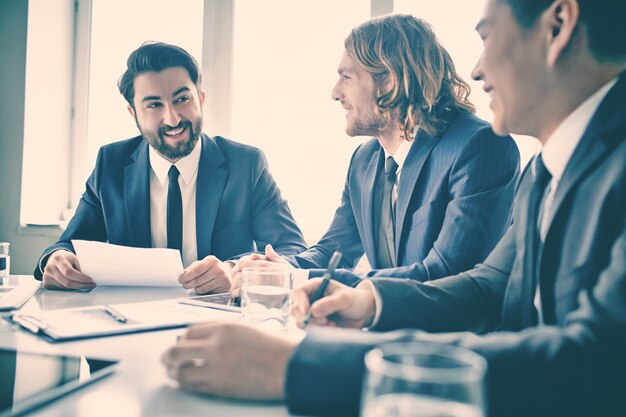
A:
34,149,107,280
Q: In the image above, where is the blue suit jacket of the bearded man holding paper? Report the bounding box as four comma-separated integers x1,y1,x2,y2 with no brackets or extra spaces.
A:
35,134,306,279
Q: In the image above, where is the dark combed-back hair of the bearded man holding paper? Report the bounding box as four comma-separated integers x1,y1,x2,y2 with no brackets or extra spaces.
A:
117,41,202,108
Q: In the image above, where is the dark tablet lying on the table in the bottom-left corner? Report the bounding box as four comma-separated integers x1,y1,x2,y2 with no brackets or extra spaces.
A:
0,348,118,417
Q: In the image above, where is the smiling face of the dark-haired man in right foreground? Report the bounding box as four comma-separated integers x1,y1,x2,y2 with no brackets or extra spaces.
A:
472,0,550,137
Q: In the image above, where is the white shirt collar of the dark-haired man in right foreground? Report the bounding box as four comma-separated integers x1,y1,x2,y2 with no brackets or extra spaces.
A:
541,77,617,182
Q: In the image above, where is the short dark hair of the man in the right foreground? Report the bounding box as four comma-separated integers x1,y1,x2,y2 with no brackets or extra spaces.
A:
501,0,626,61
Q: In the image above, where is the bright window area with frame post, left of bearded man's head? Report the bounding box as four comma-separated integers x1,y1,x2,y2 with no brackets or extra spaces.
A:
20,0,204,224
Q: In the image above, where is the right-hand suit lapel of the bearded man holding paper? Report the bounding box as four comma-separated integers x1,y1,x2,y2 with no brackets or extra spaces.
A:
196,133,228,259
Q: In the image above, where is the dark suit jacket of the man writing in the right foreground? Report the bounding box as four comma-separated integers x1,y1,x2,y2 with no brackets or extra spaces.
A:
288,74,626,417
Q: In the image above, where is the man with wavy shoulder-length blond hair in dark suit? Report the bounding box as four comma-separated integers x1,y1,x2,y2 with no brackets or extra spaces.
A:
229,15,519,290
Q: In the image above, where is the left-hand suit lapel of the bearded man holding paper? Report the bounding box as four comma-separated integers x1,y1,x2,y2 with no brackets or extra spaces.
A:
124,140,152,248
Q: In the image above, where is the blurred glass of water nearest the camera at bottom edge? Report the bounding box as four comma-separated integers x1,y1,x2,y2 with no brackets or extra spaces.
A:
361,342,487,417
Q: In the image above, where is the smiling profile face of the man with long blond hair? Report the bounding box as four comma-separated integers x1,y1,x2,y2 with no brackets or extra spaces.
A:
331,52,385,136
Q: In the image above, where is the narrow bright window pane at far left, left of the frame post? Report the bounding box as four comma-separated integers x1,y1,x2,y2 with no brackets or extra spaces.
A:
20,0,74,224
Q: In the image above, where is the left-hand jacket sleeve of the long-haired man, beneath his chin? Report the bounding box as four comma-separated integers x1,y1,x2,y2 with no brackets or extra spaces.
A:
290,148,364,270
